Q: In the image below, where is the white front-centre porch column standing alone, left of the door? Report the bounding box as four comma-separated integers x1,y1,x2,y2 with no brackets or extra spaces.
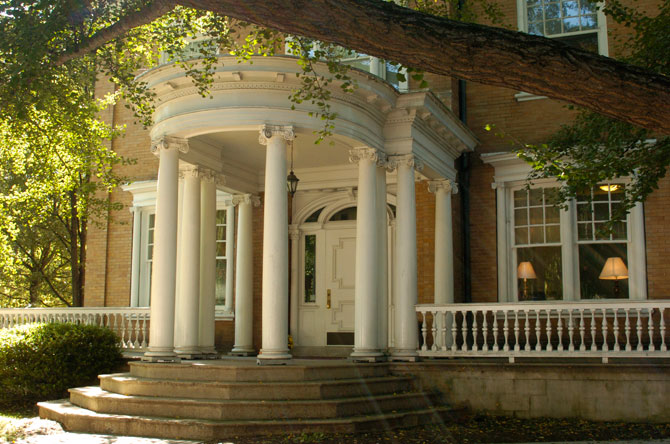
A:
258,125,294,364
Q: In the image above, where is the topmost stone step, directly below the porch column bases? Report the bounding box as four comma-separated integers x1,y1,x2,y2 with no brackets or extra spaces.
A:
130,360,389,382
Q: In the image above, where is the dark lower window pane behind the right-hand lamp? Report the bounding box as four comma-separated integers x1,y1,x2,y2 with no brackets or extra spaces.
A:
579,243,628,299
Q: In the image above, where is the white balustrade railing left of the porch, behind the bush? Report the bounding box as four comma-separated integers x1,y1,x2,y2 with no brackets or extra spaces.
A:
0,307,149,352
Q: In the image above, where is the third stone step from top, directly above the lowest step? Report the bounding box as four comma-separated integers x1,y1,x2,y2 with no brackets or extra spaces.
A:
70,387,440,421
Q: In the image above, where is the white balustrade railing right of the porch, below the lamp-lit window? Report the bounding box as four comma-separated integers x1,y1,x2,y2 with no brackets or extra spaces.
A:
416,300,670,362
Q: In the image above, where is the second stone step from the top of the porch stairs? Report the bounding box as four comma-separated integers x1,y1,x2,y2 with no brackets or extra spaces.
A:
100,373,414,400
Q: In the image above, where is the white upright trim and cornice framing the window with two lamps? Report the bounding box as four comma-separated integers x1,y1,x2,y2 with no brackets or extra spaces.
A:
482,153,647,302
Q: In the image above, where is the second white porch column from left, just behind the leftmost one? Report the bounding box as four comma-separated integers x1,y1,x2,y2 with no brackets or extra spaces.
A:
174,165,201,359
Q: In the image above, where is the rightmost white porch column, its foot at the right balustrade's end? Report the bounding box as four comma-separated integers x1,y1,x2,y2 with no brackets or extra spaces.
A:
428,179,454,304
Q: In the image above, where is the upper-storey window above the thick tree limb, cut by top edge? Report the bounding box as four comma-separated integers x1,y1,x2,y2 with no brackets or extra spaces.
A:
518,0,607,55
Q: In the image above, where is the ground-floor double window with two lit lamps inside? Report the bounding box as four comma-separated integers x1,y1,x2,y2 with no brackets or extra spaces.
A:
506,183,646,301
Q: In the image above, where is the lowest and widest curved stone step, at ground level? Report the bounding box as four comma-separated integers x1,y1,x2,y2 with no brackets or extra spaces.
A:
38,400,451,440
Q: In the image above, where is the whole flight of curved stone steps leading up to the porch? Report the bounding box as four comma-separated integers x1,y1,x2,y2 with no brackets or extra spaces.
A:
39,359,456,440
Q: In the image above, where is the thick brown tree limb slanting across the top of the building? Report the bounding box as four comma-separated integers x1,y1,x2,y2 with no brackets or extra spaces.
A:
57,0,670,134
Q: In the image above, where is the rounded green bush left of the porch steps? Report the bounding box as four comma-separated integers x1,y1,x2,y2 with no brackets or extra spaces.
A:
0,324,121,403
